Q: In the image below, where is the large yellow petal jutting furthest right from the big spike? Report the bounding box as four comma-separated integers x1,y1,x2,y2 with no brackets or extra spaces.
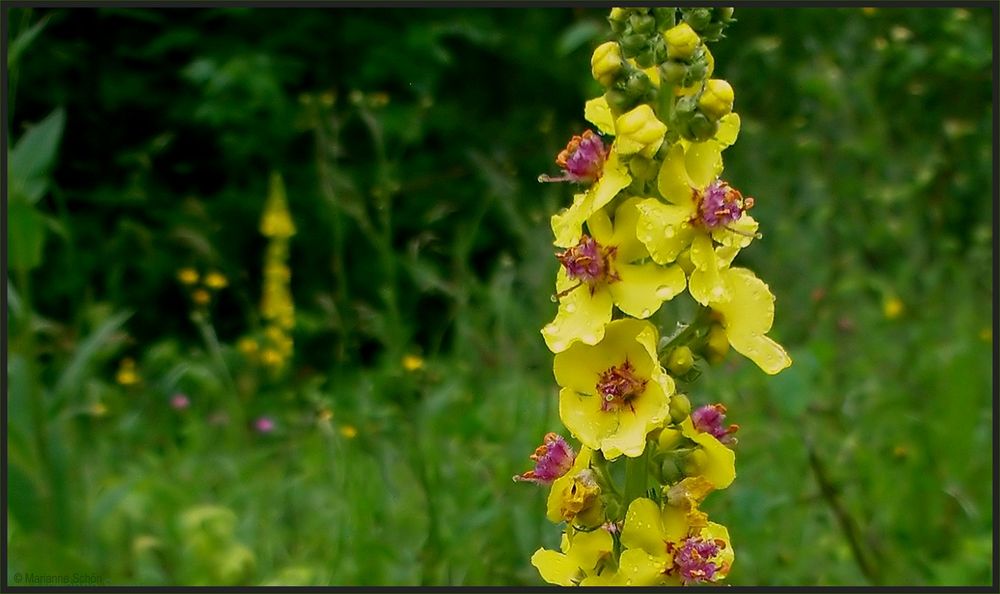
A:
709,268,792,375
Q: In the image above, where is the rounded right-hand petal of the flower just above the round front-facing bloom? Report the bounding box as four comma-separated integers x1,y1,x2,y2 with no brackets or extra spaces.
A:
610,262,687,318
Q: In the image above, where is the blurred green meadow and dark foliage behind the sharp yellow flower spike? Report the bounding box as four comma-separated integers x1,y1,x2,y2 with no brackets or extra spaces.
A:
5,7,995,585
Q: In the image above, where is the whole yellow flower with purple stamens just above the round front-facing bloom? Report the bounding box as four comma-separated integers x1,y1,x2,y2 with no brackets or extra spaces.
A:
542,198,685,353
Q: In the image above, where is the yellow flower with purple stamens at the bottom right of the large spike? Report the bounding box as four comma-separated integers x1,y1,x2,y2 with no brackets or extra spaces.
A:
621,498,734,585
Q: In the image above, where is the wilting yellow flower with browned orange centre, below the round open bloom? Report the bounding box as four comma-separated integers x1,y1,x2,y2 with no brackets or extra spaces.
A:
545,446,604,527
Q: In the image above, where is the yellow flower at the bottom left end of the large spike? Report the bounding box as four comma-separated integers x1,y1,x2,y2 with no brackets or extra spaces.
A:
531,529,614,586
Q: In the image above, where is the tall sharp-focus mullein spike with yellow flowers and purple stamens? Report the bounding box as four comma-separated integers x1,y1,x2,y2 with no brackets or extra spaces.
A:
514,8,791,586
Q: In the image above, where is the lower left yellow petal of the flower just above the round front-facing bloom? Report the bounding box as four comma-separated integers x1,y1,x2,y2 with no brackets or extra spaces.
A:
542,267,613,353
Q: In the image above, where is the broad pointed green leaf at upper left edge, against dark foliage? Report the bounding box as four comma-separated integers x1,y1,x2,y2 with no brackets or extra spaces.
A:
7,107,66,204
